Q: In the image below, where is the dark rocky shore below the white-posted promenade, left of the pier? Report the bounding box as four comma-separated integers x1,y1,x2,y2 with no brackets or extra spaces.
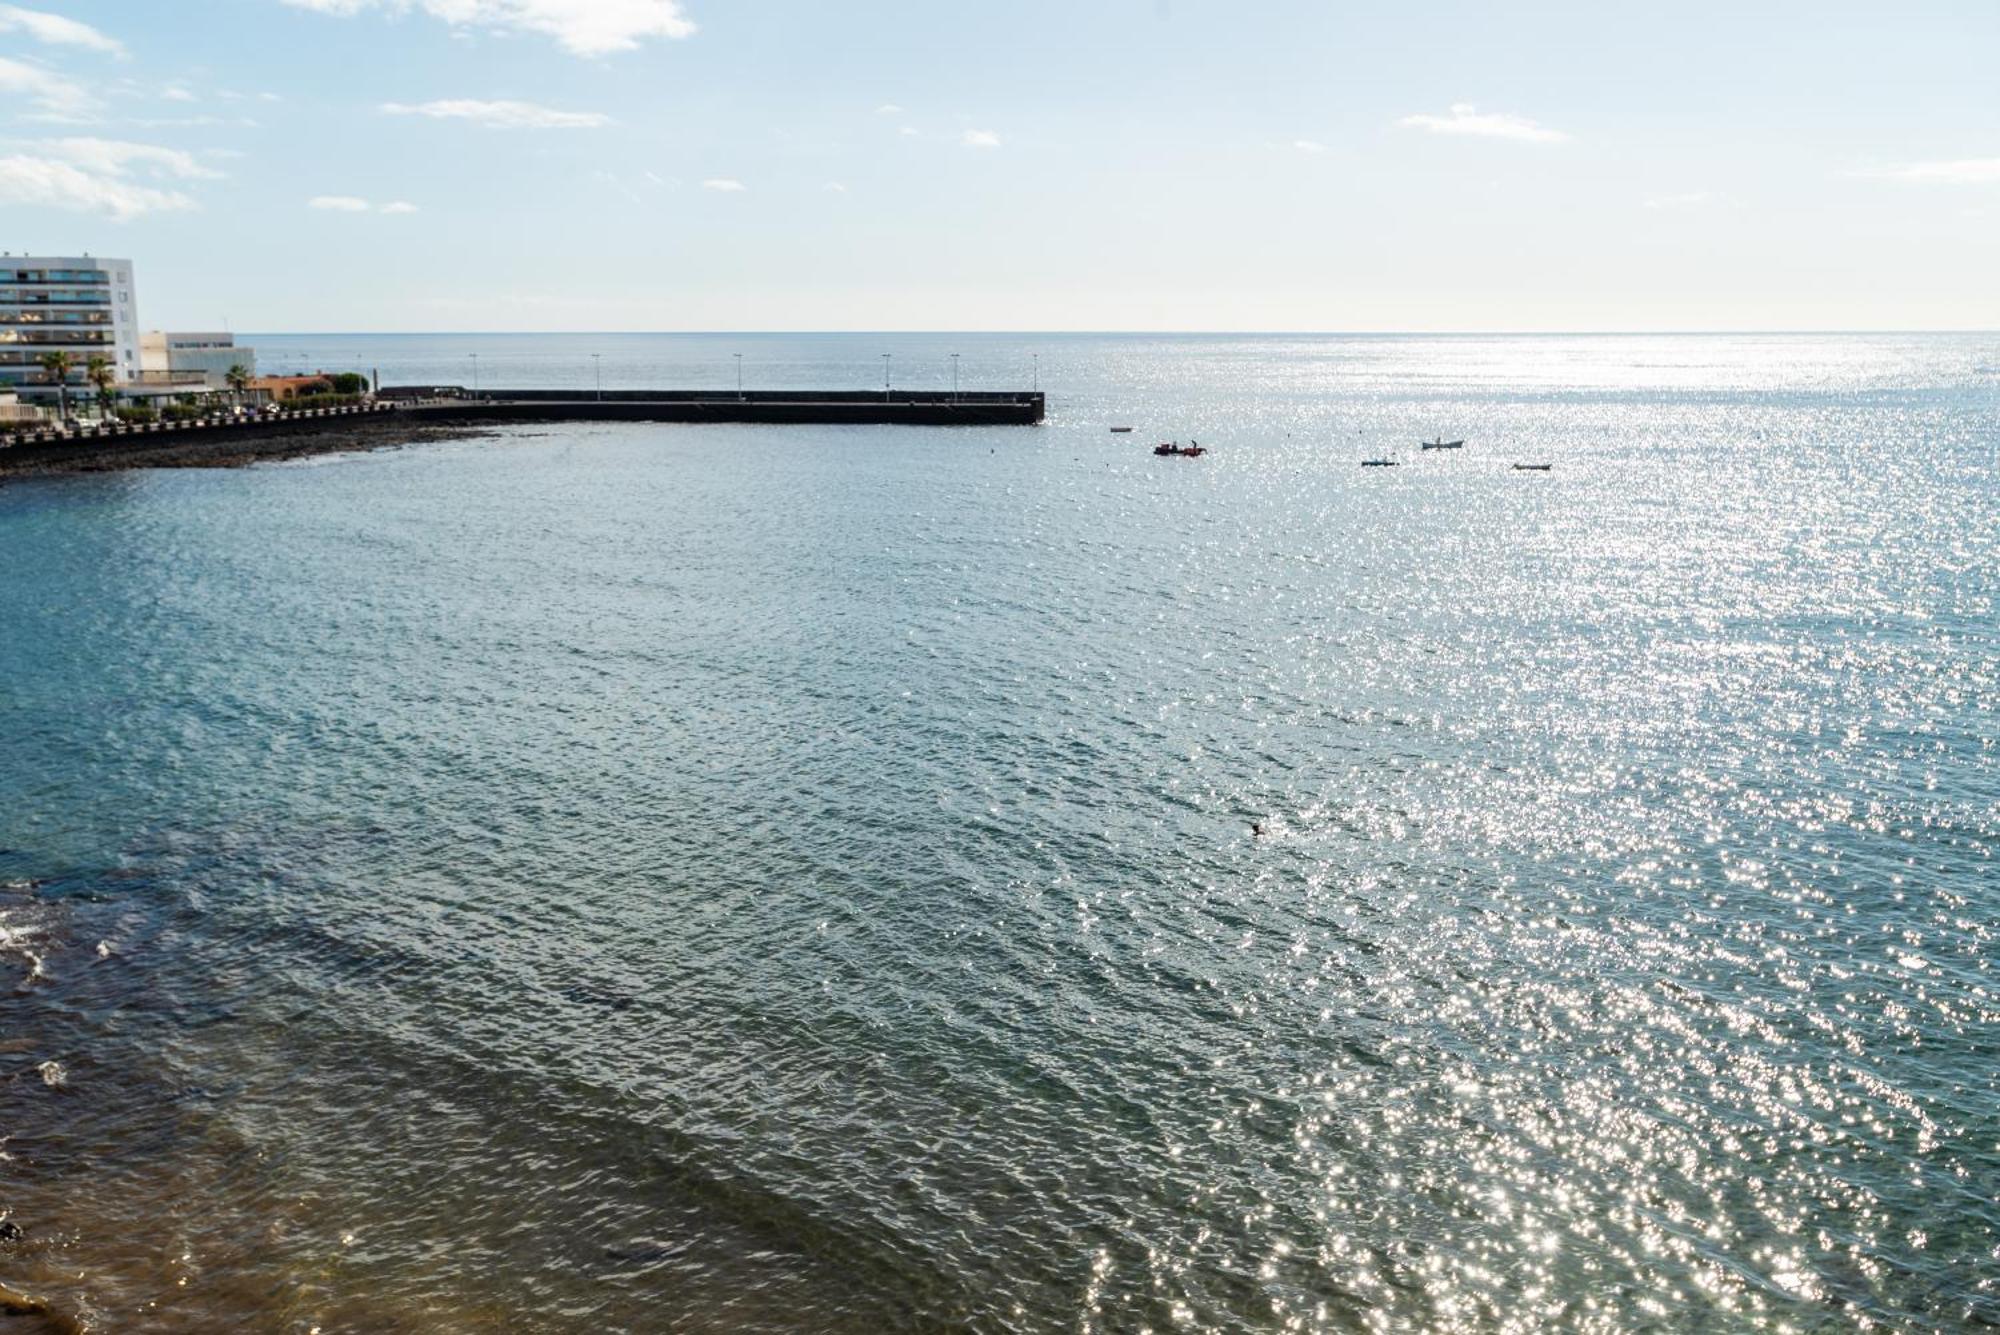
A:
0,404,486,482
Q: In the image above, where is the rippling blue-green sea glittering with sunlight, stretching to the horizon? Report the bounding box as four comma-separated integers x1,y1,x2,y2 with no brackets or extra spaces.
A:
0,336,2000,1333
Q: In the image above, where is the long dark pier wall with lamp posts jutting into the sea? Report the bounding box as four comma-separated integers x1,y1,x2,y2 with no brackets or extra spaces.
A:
380,386,1046,426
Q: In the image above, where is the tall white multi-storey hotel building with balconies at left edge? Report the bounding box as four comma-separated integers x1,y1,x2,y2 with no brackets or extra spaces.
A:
0,254,140,392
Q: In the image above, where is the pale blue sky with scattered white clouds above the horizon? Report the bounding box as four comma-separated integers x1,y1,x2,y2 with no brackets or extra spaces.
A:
0,0,2000,332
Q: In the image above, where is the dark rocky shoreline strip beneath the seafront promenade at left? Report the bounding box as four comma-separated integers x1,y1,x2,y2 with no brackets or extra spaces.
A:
0,412,492,484
